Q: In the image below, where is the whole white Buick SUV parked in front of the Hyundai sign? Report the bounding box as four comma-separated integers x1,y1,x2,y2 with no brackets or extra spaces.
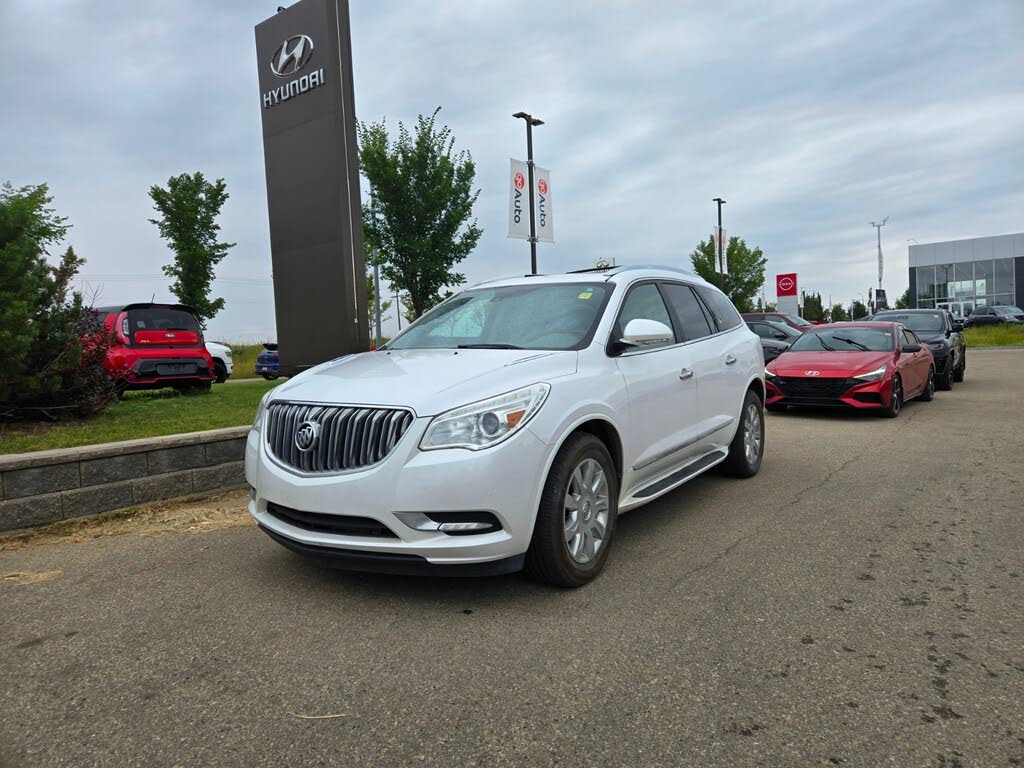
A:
246,267,764,586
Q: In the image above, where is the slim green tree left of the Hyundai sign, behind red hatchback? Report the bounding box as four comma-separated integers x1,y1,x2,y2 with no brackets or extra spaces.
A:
150,171,234,328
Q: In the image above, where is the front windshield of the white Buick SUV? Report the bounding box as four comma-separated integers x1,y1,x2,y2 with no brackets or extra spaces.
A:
387,283,612,349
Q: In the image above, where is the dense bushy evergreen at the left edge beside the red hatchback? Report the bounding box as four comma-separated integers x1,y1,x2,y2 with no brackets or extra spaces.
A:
0,183,113,420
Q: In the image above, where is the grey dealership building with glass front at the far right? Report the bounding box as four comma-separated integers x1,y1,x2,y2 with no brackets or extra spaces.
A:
909,232,1024,316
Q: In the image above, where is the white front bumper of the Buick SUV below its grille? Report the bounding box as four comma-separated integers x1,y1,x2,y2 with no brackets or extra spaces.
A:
246,418,550,574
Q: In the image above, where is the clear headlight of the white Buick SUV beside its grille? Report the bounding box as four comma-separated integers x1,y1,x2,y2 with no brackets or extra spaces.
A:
420,384,551,451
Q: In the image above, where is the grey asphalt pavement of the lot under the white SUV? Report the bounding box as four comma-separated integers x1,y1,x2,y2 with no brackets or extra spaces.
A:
0,349,1024,768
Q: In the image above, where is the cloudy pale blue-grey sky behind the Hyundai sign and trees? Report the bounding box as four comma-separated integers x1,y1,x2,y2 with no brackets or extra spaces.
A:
0,0,1024,341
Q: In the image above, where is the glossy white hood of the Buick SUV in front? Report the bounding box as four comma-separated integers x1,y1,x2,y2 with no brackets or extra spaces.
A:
272,349,578,416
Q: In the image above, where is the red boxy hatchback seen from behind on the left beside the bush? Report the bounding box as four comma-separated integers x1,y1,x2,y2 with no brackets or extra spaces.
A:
96,303,214,390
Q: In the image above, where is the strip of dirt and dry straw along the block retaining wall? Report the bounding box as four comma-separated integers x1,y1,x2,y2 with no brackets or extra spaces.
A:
0,489,254,548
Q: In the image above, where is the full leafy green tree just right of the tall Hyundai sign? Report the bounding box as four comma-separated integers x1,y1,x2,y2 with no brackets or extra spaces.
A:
358,106,483,319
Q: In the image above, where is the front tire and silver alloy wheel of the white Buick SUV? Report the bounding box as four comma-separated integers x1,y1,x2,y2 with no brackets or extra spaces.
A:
524,432,618,587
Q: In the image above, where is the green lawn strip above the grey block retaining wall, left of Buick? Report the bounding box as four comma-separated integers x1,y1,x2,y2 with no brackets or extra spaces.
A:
0,380,280,455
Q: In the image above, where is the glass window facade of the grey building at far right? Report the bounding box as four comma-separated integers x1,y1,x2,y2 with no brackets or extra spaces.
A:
914,259,1016,312
